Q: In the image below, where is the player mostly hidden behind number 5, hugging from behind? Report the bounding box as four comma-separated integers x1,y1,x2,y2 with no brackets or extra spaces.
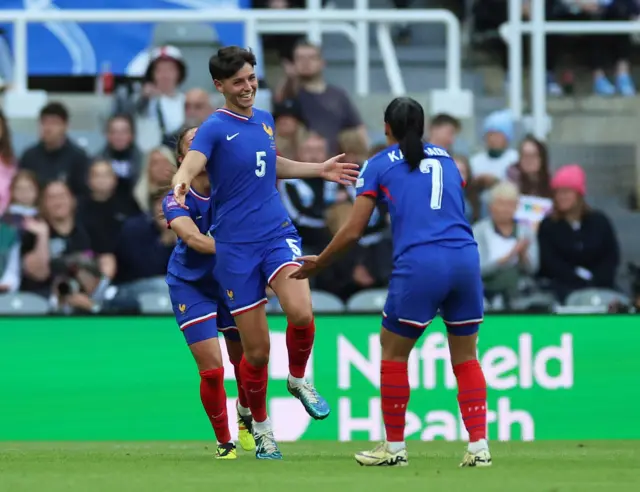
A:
162,128,255,460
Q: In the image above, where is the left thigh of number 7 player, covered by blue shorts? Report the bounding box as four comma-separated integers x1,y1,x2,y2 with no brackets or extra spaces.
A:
382,258,447,340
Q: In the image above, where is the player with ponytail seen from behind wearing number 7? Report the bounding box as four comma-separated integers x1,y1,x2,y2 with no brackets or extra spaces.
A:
291,98,491,466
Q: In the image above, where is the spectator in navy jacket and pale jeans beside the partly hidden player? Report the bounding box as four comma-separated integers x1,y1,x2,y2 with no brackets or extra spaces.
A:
116,192,176,299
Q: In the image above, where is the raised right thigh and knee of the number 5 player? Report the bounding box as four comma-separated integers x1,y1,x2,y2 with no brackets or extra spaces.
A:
263,234,313,326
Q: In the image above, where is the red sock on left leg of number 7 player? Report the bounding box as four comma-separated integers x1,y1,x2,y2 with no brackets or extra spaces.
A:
380,360,410,442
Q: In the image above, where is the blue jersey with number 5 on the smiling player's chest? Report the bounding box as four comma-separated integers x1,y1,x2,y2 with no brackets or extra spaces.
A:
191,109,292,243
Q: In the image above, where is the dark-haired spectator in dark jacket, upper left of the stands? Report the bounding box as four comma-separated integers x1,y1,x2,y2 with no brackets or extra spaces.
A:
20,102,89,196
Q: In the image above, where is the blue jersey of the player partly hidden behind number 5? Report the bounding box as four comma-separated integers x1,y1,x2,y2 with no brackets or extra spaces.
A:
162,189,216,281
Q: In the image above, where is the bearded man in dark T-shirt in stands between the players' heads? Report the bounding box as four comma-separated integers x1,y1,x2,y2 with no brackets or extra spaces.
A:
276,41,368,154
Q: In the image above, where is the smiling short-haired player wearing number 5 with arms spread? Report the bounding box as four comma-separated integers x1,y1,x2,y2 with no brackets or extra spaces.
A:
174,46,358,459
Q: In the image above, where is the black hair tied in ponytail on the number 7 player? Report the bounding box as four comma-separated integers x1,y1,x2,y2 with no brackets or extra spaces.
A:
384,97,424,171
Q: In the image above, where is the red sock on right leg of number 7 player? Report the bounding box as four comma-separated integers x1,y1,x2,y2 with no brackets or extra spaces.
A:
453,360,487,442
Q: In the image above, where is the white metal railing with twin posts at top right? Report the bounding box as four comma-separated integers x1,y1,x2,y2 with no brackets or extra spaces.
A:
500,0,640,139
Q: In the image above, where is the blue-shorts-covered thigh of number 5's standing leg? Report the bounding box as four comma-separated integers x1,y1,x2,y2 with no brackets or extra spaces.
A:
214,242,267,317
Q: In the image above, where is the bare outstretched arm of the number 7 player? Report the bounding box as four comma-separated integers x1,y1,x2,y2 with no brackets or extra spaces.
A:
289,196,376,279
